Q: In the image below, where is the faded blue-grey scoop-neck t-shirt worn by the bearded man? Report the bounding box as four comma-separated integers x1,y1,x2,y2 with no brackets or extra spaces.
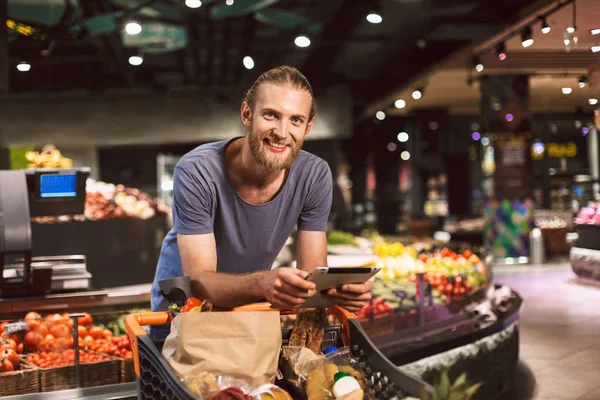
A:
152,139,332,311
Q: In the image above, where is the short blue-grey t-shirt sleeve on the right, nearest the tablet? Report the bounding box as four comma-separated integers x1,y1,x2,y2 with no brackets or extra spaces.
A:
298,161,333,231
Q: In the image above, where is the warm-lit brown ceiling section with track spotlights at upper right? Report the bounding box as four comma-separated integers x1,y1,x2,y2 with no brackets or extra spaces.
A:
365,0,600,115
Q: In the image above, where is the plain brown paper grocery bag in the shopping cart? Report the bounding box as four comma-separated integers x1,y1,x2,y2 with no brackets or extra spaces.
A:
162,311,281,386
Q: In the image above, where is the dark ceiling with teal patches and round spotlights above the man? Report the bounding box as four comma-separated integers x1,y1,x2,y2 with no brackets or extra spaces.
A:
0,0,547,108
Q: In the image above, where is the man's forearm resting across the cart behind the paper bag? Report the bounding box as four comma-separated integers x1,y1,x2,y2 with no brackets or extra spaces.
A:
191,271,266,309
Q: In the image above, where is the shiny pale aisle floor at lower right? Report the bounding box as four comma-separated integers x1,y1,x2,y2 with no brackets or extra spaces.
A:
494,264,600,400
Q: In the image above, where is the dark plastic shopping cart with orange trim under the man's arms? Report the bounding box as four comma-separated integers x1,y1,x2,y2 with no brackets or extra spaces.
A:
125,303,433,400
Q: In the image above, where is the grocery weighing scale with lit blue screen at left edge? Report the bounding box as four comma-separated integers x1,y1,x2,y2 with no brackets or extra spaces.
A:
0,168,92,297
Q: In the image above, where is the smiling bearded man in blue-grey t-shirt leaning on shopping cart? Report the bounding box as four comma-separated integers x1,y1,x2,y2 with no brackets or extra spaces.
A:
152,66,372,338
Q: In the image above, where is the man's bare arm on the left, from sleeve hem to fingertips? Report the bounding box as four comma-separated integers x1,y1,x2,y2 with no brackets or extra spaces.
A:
177,233,315,309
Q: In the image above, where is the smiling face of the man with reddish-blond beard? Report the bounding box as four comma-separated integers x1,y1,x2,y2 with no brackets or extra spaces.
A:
242,83,314,172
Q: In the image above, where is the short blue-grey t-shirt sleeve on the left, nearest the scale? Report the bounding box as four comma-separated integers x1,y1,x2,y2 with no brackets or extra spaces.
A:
173,166,213,235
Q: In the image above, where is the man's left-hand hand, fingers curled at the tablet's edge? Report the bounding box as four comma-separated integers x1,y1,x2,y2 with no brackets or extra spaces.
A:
260,268,317,309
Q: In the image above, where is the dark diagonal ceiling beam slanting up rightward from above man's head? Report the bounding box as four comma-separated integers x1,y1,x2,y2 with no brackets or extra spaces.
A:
301,0,372,85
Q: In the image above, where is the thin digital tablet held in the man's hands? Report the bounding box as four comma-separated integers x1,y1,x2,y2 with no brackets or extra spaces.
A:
299,267,381,308
